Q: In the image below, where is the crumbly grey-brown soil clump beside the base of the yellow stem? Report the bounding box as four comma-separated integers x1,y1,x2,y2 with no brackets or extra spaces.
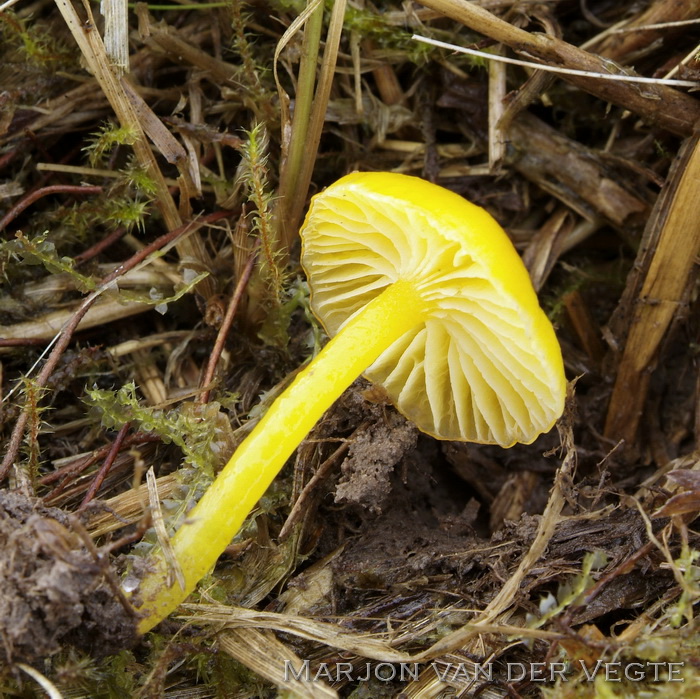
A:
0,490,136,661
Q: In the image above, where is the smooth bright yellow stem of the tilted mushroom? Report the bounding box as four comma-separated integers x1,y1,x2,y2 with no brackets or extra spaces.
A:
132,280,427,633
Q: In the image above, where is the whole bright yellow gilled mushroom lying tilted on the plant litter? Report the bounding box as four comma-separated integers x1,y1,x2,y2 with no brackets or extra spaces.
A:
132,173,566,632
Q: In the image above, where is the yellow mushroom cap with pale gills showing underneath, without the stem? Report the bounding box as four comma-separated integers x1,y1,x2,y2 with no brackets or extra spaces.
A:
301,173,566,447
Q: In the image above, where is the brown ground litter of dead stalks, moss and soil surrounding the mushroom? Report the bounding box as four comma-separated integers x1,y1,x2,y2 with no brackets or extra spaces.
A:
0,0,700,697
